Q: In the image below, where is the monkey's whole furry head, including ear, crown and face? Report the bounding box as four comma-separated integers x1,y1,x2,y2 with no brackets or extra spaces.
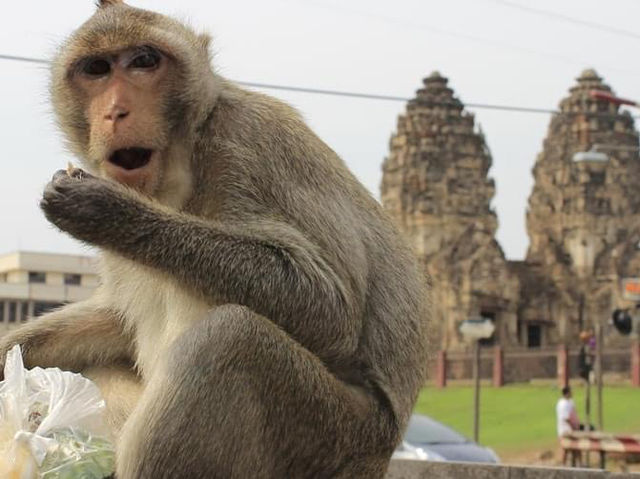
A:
50,0,220,203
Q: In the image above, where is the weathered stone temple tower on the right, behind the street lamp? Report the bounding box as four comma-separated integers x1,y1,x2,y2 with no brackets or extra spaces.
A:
514,70,640,344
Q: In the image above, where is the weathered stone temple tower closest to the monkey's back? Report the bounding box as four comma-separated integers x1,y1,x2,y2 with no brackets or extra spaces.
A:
381,72,519,349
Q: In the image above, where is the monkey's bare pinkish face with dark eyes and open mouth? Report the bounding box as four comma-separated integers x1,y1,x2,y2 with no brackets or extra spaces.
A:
70,45,173,195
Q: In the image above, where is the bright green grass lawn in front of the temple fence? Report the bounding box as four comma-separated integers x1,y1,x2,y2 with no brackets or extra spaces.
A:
415,382,640,454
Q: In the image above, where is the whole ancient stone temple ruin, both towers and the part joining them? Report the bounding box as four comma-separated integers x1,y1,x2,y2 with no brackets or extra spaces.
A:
381,70,640,350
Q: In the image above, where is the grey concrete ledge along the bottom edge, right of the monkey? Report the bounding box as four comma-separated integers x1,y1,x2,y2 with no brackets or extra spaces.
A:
386,460,640,479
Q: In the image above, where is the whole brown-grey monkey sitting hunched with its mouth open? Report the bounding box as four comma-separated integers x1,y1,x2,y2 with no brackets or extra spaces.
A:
0,0,429,479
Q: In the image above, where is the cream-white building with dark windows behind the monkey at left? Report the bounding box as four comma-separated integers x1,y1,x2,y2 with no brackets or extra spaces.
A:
0,251,98,335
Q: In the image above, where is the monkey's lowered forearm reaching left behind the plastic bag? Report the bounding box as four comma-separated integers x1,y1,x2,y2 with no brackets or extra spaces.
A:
0,299,132,371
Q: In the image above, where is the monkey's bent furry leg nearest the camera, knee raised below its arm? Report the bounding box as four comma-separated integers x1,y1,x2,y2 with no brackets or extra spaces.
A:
116,306,397,479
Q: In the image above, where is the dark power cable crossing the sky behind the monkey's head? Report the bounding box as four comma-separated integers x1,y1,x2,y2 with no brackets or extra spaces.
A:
0,53,636,116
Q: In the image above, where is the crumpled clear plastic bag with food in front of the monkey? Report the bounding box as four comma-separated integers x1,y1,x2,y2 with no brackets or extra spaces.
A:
0,346,115,479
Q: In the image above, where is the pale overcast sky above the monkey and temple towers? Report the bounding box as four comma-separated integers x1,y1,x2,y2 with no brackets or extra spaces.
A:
0,0,640,259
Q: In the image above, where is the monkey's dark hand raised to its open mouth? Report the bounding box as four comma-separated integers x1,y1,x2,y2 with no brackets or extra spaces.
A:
40,168,141,246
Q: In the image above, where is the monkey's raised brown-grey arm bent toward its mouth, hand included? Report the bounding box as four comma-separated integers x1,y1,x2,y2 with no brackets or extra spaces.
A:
41,173,361,356
